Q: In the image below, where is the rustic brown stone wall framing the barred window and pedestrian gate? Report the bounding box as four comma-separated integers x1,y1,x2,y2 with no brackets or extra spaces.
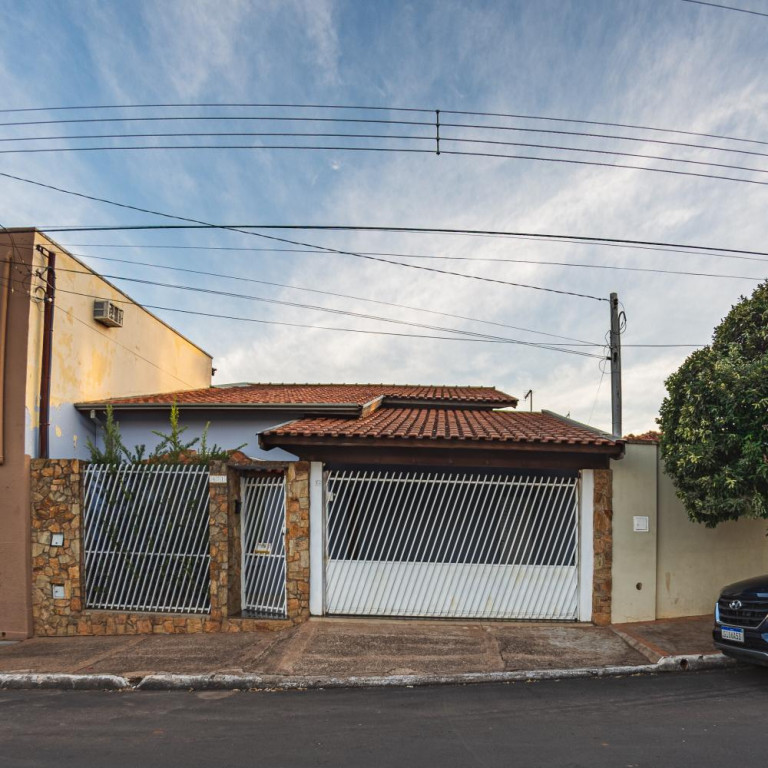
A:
31,459,309,636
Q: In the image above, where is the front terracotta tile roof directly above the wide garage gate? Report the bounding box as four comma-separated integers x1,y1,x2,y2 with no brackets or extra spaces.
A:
263,407,617,446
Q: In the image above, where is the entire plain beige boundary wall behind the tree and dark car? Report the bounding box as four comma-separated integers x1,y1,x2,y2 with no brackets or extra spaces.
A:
612,443,768,623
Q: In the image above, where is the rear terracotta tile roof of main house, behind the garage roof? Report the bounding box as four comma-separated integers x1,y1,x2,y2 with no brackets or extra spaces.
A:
79,384,517,407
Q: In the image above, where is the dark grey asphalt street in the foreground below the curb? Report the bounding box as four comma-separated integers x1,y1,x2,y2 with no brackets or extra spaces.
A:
0,667,768,768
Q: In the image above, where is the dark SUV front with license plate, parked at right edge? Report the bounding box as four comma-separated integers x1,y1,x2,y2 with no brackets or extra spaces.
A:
712,575,768,666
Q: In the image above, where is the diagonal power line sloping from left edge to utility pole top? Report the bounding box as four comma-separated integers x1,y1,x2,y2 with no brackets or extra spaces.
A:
0,173,608,301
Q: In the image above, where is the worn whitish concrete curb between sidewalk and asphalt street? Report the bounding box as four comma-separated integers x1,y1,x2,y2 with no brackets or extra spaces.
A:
0,653,736,691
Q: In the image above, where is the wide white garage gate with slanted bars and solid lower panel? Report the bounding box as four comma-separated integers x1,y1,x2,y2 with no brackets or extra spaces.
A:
326,470,578,620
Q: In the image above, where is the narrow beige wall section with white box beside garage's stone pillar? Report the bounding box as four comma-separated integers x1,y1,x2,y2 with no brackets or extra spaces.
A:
611,444,657,623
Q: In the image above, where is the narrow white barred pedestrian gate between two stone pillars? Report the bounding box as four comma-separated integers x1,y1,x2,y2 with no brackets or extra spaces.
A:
240,474,286,617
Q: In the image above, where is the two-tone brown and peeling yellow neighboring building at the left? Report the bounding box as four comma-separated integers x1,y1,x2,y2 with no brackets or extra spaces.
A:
0,229,211,639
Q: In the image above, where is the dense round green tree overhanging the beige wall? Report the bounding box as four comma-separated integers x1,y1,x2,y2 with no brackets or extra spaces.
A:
658,282,768,528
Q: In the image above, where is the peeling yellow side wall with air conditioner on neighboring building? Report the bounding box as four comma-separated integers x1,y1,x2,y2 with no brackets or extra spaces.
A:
26,233,212,458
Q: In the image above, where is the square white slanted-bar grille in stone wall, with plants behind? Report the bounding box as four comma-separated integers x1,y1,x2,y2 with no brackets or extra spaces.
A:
83,464,210,613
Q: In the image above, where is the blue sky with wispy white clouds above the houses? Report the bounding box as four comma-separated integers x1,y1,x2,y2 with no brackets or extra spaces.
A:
0,0,768,433
